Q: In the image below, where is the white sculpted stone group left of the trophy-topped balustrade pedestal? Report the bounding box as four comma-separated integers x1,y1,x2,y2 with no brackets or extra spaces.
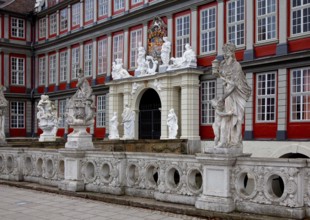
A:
37,95,58,142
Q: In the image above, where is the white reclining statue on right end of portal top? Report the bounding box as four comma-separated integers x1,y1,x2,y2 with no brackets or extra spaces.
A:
168,44,197,70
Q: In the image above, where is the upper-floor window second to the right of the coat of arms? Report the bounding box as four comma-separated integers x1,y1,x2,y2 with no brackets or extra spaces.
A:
200,7,216,54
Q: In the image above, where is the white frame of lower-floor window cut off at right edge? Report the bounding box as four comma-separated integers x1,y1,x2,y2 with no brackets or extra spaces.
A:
290,66,310,122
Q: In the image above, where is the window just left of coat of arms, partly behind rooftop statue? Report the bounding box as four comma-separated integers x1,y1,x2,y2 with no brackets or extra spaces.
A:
130,29,142,68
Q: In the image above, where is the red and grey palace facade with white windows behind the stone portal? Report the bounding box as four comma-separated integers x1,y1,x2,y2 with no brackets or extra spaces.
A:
0,0,310,157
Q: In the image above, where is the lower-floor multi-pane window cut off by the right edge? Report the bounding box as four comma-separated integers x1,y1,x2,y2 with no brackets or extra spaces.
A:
290,67,310,121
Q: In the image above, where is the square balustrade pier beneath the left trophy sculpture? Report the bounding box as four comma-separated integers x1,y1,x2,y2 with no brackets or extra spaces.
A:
58,149,85,192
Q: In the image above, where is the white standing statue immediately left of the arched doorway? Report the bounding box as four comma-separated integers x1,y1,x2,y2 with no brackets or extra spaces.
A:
122,104,135,139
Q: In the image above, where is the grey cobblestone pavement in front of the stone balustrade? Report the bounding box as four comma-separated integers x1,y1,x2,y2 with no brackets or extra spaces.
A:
0,185,203,220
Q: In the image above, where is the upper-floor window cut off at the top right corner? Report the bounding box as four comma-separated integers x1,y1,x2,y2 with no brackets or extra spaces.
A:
291,0,310,35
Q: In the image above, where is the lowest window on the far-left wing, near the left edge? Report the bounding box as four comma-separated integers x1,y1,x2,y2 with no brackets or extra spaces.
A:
10,101,25,128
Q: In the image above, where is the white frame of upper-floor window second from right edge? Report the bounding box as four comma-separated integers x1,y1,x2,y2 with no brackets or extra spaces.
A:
255,0,278,43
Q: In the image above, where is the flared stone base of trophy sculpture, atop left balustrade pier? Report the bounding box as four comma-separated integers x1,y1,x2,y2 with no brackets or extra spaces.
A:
65,126,94,149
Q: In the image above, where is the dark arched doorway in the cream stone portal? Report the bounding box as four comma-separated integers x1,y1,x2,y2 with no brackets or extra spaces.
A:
139,89,161,139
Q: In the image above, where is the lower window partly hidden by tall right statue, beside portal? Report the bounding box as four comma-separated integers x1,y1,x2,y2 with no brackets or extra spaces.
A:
201,80,216,124
